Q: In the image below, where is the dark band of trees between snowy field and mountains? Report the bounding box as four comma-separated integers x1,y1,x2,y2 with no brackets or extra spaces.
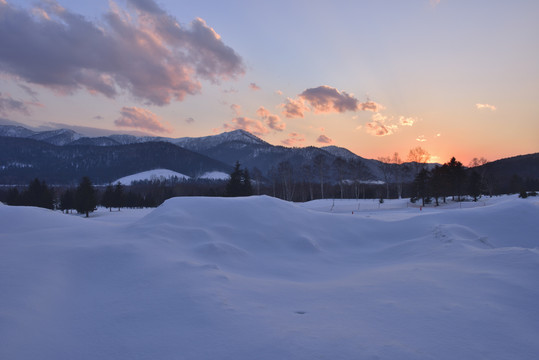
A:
0,154,539,215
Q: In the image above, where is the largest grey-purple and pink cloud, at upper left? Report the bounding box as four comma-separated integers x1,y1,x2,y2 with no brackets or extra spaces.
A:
0,0,245,105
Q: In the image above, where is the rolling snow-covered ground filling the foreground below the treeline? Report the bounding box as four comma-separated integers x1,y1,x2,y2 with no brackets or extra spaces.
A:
0,196,539,360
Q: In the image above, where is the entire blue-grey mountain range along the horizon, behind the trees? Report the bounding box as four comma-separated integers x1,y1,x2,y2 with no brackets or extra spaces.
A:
0,125,539,184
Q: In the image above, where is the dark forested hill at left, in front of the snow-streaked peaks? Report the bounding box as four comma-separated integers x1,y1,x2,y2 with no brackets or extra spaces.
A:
0,137,232,184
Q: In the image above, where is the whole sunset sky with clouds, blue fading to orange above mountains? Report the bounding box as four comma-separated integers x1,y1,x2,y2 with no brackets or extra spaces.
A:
0,0,539,165
